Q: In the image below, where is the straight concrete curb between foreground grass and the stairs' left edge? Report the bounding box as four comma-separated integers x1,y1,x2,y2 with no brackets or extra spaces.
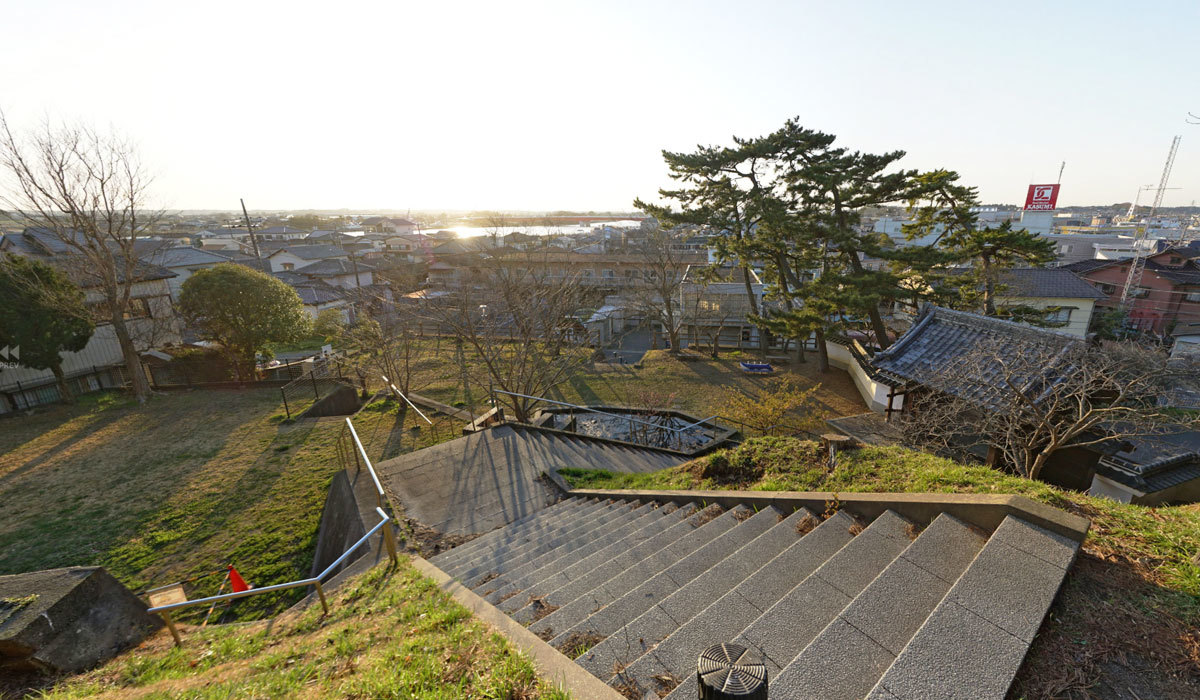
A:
412,556,624,700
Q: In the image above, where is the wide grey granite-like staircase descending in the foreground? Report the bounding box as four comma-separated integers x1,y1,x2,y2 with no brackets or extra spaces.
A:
431,497,1079,700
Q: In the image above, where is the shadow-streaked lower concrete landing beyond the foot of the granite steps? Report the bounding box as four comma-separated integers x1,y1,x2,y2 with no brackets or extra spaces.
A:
376,425,682,536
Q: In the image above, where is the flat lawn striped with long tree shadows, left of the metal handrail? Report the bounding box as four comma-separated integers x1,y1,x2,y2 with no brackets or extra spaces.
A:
0,389,456,620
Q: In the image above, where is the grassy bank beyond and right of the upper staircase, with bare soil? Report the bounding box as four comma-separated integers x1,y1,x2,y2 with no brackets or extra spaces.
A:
562,438,1200,700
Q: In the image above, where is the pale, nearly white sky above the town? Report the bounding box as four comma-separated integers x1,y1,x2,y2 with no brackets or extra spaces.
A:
0,0,1200,210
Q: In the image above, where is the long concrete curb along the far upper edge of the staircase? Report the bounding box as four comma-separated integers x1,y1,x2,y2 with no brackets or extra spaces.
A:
568,489,1092,543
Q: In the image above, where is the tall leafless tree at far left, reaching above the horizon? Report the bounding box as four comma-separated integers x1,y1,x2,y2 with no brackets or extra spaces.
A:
0,113,160,401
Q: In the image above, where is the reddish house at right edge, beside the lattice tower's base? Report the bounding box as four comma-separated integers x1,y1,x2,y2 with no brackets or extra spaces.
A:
1064,243,1200,336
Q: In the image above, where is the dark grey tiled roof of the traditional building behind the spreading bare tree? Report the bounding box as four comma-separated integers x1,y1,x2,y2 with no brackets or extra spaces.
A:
871,305,1081,405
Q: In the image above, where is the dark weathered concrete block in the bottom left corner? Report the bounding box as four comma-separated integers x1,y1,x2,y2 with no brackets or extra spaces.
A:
0,567,162,674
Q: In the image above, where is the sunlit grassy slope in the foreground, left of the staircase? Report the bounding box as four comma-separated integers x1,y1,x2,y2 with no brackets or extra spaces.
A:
18,562,568,700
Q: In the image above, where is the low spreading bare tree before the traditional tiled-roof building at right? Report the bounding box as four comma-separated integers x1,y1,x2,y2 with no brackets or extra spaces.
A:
901,341,1198,479
